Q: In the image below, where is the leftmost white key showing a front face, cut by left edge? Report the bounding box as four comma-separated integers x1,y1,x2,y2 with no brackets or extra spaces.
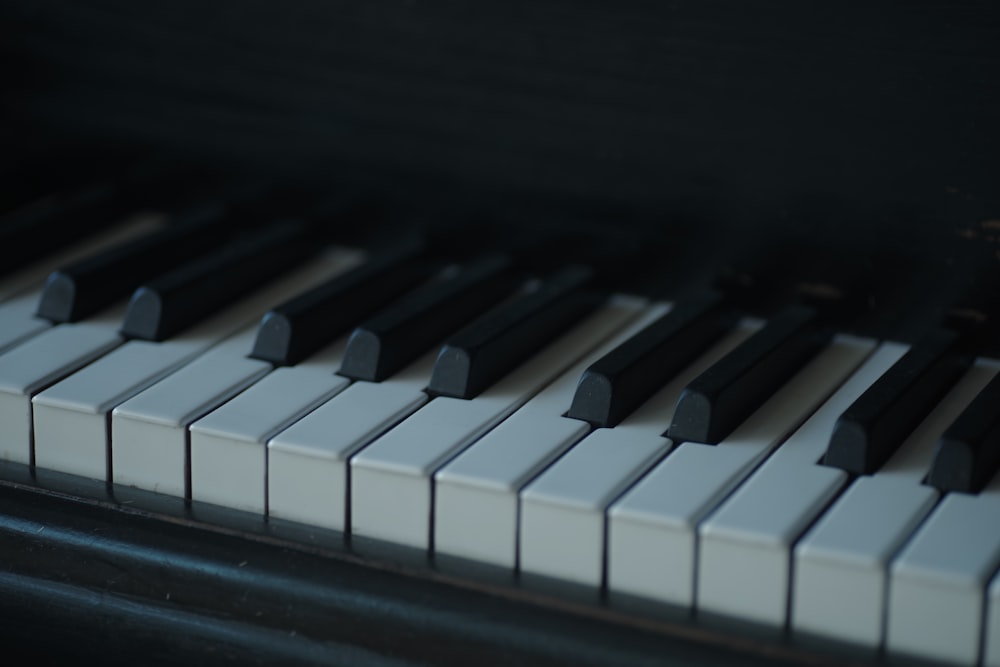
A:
0,306,124,464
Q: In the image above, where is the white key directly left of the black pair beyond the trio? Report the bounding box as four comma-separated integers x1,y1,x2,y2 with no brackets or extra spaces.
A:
434,303,670,570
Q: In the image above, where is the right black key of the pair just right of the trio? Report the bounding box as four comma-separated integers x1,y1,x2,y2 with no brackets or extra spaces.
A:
664,305,831,445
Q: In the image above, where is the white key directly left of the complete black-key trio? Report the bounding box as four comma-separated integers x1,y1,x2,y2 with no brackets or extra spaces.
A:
111,325,272,497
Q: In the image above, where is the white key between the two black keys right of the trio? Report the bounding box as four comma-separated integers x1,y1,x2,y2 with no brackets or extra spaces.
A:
519,320,760,587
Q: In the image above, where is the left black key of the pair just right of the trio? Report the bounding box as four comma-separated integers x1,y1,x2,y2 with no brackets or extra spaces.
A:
566,294,735,427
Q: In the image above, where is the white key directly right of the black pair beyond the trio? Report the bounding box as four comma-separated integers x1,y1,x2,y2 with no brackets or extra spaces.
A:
609,337,864,607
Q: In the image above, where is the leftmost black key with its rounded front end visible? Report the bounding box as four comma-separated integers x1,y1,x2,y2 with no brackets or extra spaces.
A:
35,204,230,323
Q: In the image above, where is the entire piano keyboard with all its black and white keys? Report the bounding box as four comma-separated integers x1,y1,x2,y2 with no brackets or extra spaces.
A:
0,185,1000,665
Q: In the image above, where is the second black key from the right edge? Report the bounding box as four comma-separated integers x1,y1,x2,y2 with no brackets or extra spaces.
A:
823,331,970,475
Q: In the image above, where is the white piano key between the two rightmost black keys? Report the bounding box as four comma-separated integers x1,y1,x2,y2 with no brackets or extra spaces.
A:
792,364,996,648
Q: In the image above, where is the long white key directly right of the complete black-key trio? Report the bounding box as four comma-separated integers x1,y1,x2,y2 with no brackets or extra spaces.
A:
350,297,645,549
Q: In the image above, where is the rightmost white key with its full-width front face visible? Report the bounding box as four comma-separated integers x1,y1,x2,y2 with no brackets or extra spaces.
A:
886,475,1000,665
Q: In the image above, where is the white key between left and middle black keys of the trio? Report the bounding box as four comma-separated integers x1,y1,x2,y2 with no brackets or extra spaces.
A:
189,336,350,514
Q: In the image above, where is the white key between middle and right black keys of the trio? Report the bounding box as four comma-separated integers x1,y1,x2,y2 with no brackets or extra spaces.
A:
267,350,437,531
